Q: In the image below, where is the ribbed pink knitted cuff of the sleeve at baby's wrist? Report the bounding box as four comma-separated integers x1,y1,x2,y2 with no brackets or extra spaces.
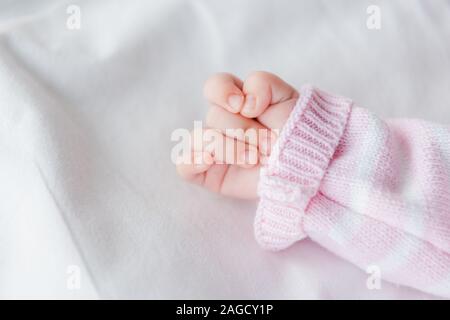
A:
255,86,352,250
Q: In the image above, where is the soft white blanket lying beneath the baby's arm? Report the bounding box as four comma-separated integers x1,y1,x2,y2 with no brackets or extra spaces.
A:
0,0,450,299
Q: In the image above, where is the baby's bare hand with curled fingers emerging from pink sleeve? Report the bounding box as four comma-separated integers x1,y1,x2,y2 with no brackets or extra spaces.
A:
177,71,299,199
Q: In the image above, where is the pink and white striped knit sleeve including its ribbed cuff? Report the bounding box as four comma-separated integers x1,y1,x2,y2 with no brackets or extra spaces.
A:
255,86,450,297
